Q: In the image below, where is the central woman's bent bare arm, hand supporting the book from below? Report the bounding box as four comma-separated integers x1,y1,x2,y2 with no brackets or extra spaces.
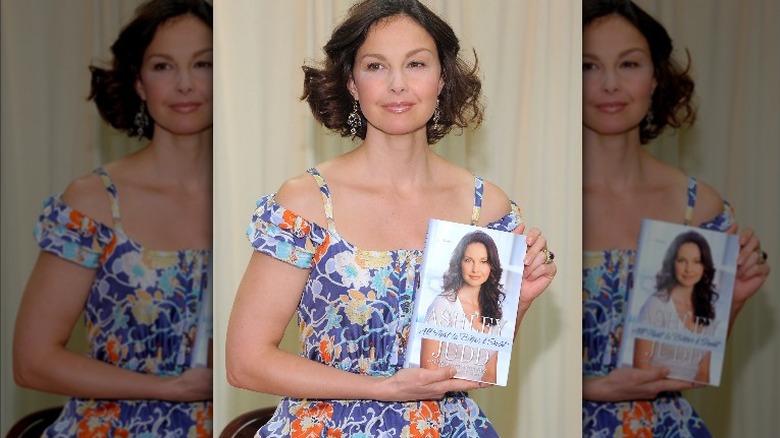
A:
225,252,479,401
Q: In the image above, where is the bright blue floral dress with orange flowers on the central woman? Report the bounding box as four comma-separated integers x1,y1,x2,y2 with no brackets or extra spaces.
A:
248,169,522,438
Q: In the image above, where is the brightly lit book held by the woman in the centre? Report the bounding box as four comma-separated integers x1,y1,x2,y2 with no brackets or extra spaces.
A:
404,219,526,386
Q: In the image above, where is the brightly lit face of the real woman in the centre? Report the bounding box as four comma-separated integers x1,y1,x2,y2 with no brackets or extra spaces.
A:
348,15,444,139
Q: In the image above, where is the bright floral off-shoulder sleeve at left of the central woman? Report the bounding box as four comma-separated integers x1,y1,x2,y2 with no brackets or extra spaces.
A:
247,195,328,269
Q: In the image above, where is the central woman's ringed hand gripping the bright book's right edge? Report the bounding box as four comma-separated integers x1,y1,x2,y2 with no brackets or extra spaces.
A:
515,224,558,310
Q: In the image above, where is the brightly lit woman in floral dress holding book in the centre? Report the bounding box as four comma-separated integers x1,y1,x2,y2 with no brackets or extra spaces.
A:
226,0,556,436
